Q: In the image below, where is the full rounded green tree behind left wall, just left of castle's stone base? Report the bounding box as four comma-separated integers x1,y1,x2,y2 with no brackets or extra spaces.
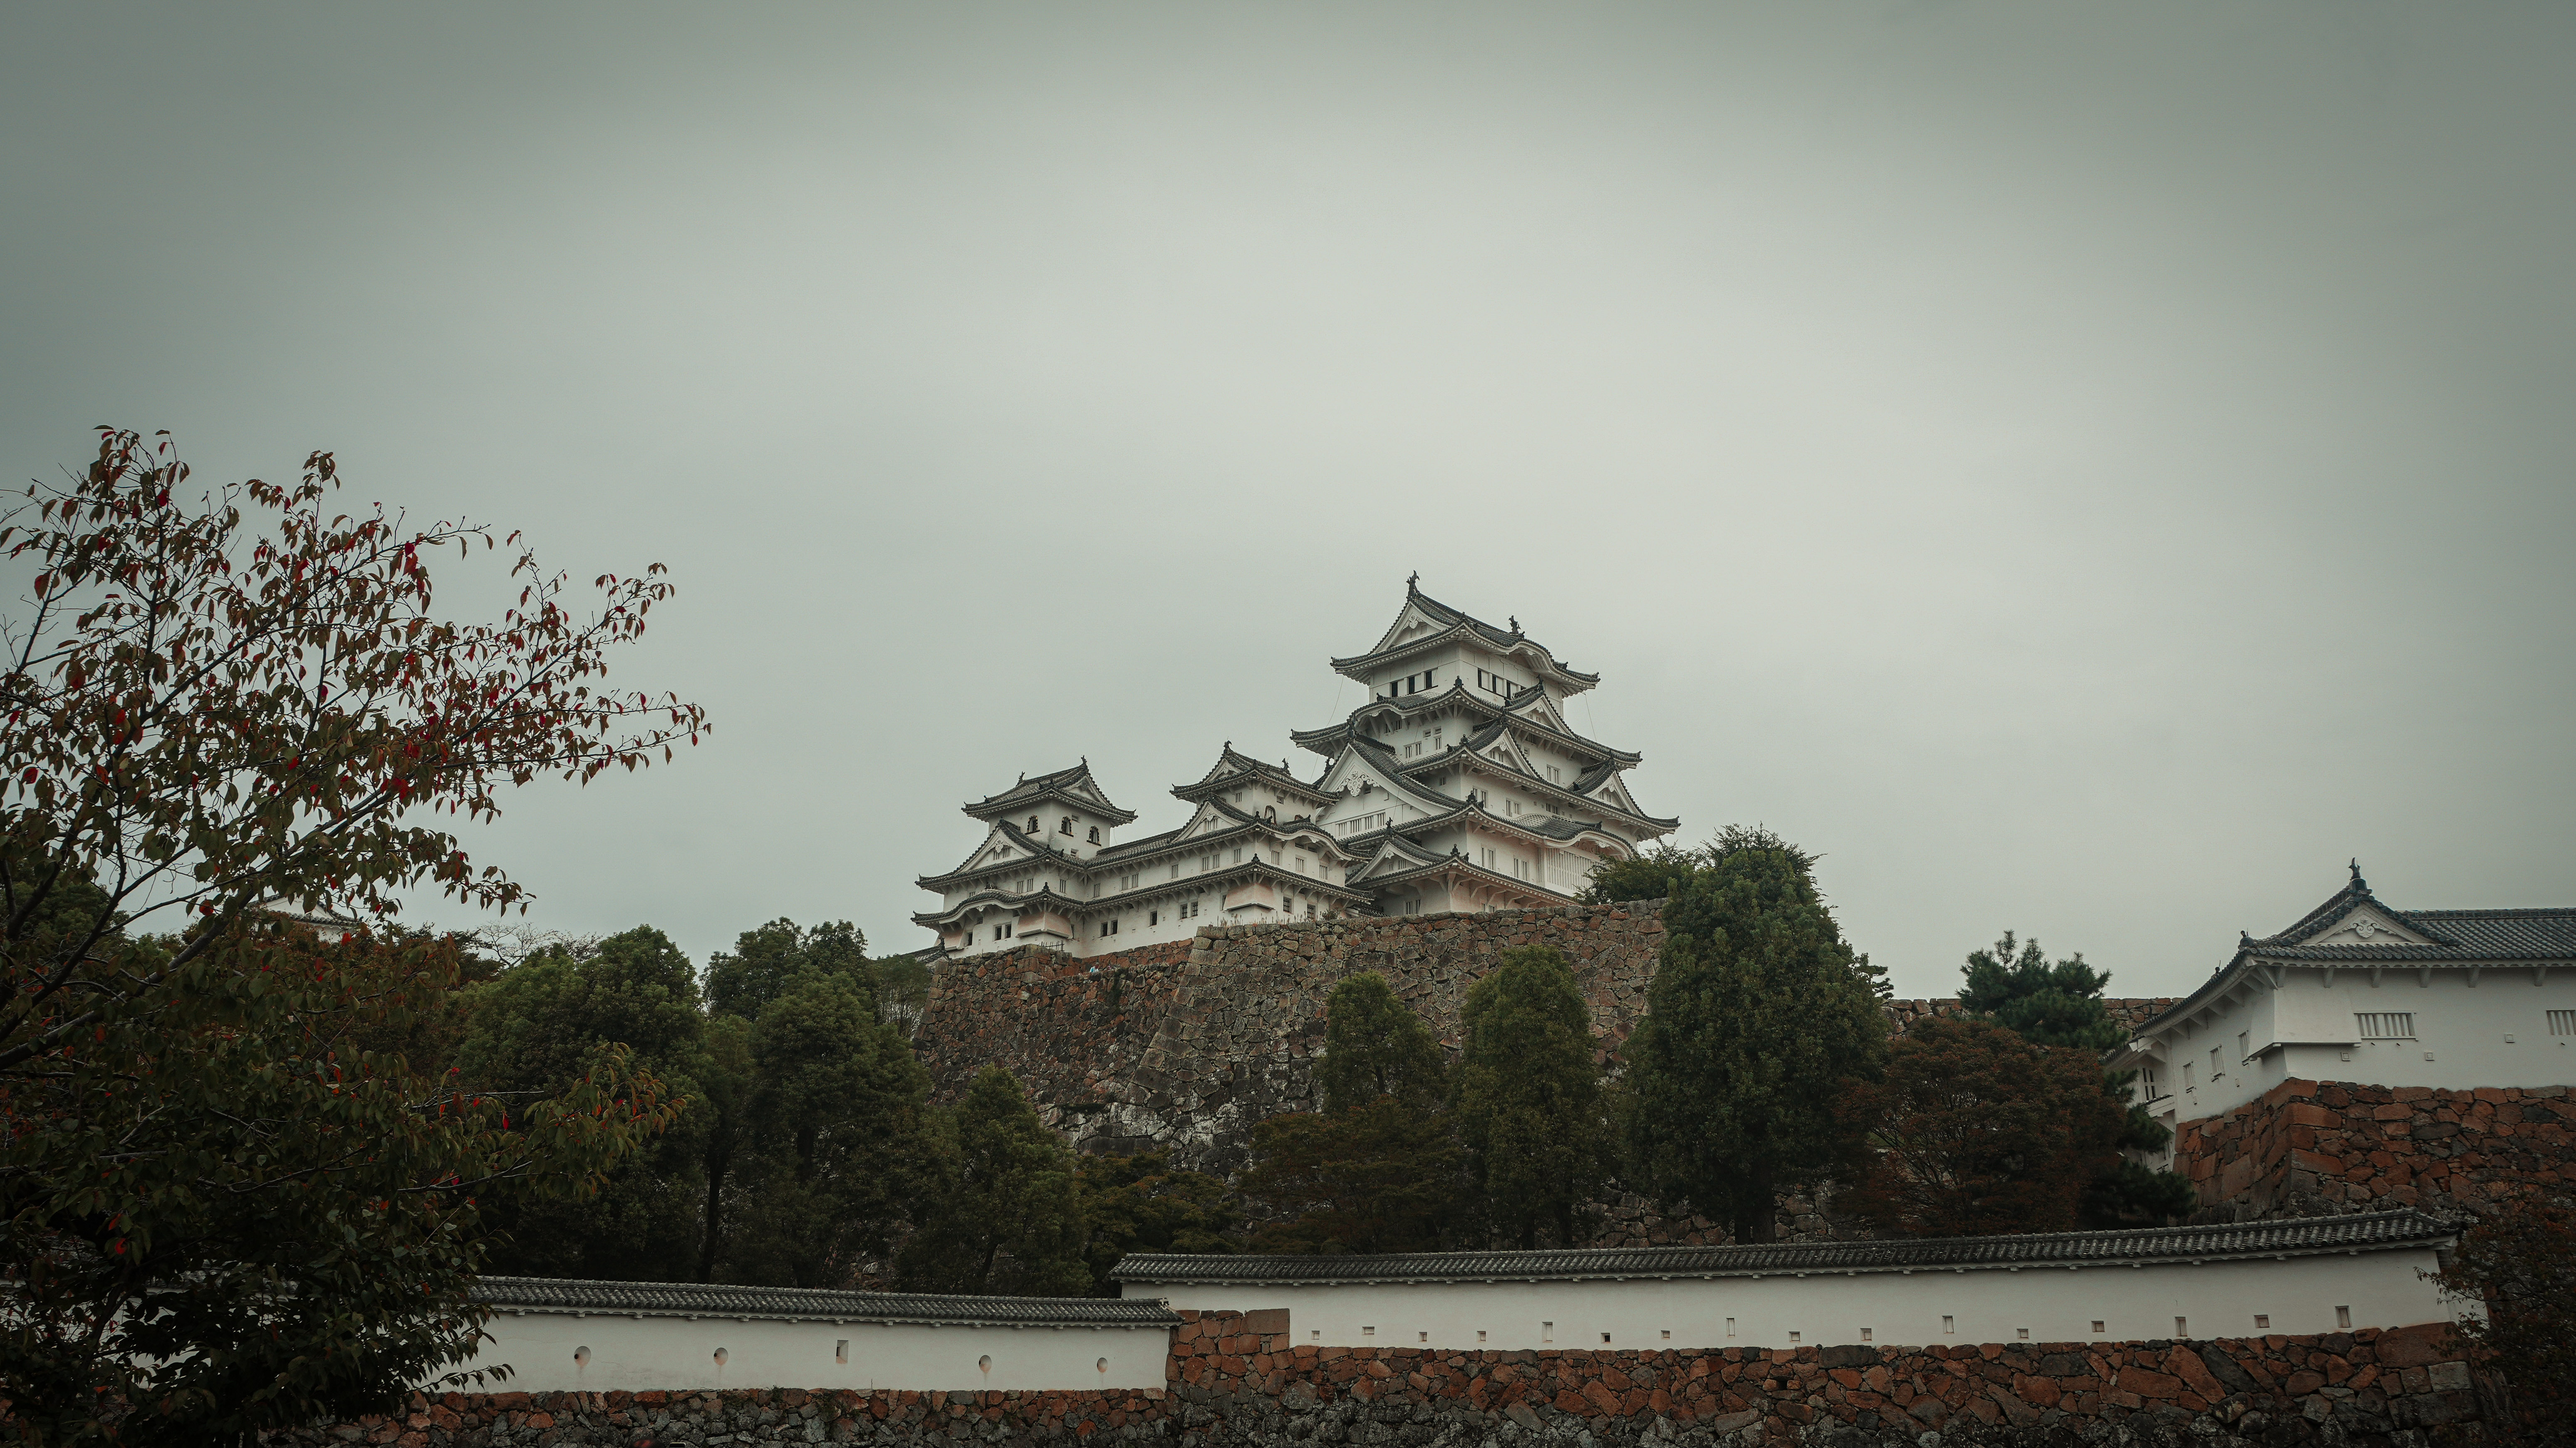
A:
716,974,935,1288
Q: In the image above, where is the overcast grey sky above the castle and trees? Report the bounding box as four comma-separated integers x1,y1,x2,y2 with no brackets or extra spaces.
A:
0,0,2576,995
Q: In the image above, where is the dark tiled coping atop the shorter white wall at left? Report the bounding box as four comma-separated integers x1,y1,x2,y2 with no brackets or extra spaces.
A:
474,1278,1180,1327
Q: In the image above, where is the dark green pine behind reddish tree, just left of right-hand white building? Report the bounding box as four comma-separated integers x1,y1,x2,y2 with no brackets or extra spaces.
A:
1958,930,2200,1226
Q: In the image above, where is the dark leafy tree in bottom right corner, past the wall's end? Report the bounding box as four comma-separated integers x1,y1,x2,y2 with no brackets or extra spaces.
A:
2440,1191,2576,1448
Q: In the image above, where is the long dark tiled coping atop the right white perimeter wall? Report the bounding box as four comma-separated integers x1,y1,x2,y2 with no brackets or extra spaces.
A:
1110,1211,2457,1283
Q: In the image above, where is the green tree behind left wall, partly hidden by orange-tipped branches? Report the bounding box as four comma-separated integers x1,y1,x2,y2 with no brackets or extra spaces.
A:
456,925,719,1280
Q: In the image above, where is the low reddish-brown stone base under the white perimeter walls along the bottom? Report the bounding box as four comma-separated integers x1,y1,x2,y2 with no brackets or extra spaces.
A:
270,1312,2486,1448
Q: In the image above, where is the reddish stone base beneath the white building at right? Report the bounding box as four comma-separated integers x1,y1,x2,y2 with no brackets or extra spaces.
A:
2174,1079,2576,1216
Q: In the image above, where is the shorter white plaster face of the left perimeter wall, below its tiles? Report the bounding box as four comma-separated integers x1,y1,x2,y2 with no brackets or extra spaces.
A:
466,1312,1172,1394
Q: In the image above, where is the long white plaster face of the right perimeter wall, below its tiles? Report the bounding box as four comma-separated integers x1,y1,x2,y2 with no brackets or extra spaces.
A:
1123,1247,2452,1350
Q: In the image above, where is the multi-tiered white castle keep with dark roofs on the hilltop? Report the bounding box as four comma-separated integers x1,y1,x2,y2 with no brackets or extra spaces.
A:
912,582,1679,956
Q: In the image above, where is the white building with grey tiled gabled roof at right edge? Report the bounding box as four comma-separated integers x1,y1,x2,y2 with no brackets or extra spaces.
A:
2110,861,2576,1144
